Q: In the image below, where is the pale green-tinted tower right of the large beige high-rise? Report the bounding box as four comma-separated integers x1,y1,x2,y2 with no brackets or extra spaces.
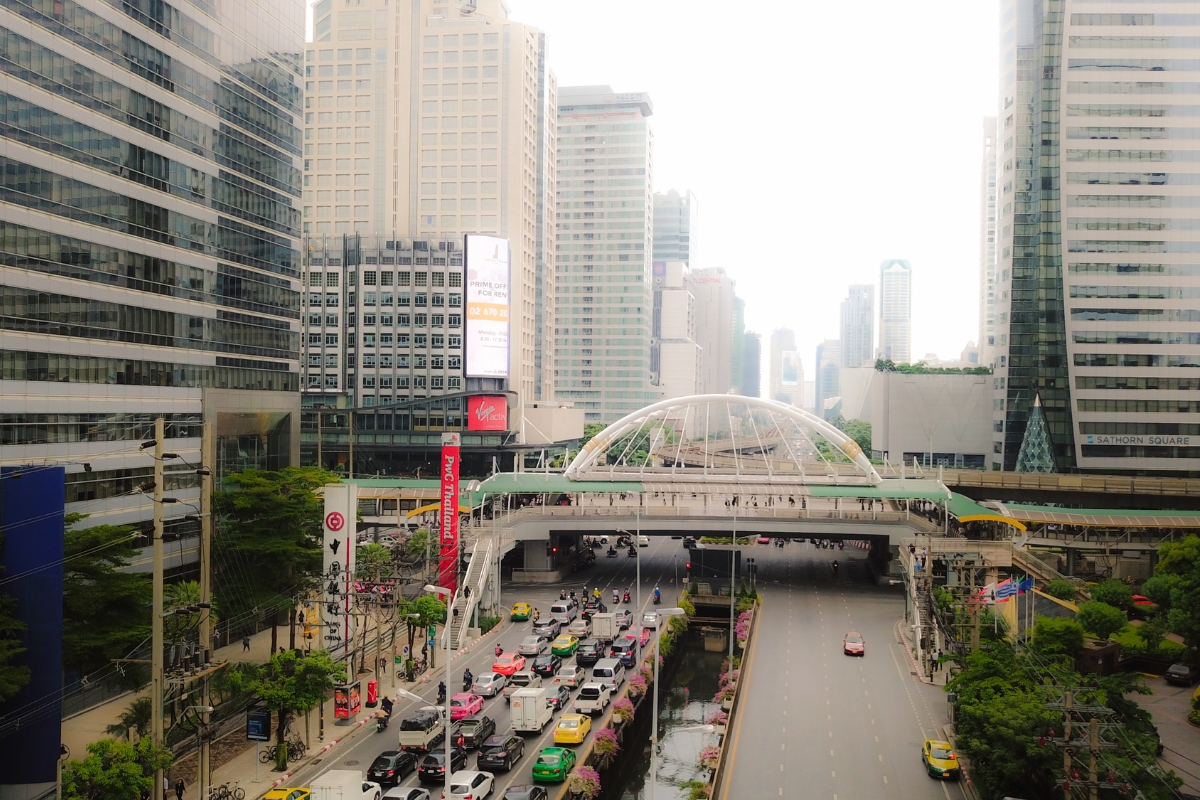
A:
554,86,660,422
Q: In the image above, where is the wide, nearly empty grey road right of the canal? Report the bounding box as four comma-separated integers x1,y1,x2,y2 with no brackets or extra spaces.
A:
721,542,964,800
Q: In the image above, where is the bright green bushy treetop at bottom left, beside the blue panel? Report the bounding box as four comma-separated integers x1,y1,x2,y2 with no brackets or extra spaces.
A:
62,739,174,800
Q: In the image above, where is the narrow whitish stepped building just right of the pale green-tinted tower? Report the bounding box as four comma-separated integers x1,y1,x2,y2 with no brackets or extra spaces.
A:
650,261,703,398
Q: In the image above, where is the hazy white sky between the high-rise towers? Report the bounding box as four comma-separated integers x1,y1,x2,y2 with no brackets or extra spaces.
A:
508,0,998,376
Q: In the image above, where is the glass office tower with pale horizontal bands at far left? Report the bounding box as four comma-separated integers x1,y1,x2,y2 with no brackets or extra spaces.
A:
0,0,305,537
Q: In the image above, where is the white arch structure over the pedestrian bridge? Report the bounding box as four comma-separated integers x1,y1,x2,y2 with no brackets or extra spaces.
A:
566,395,882,485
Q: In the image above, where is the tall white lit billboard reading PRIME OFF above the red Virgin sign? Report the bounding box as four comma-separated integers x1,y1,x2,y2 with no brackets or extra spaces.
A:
463,234,511,378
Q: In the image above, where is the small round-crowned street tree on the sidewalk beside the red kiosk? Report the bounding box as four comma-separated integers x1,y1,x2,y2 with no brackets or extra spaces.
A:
251,650,346,772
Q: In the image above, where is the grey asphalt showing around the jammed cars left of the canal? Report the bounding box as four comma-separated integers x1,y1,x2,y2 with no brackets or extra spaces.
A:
288,537,686,798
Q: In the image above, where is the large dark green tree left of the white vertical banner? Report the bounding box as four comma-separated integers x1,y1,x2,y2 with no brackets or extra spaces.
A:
214,467,338,620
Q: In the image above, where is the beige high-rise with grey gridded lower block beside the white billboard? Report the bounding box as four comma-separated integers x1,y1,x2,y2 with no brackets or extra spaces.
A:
304,0,557,409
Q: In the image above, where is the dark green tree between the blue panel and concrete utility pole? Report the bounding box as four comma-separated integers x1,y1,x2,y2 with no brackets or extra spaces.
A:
62,515,151,675
